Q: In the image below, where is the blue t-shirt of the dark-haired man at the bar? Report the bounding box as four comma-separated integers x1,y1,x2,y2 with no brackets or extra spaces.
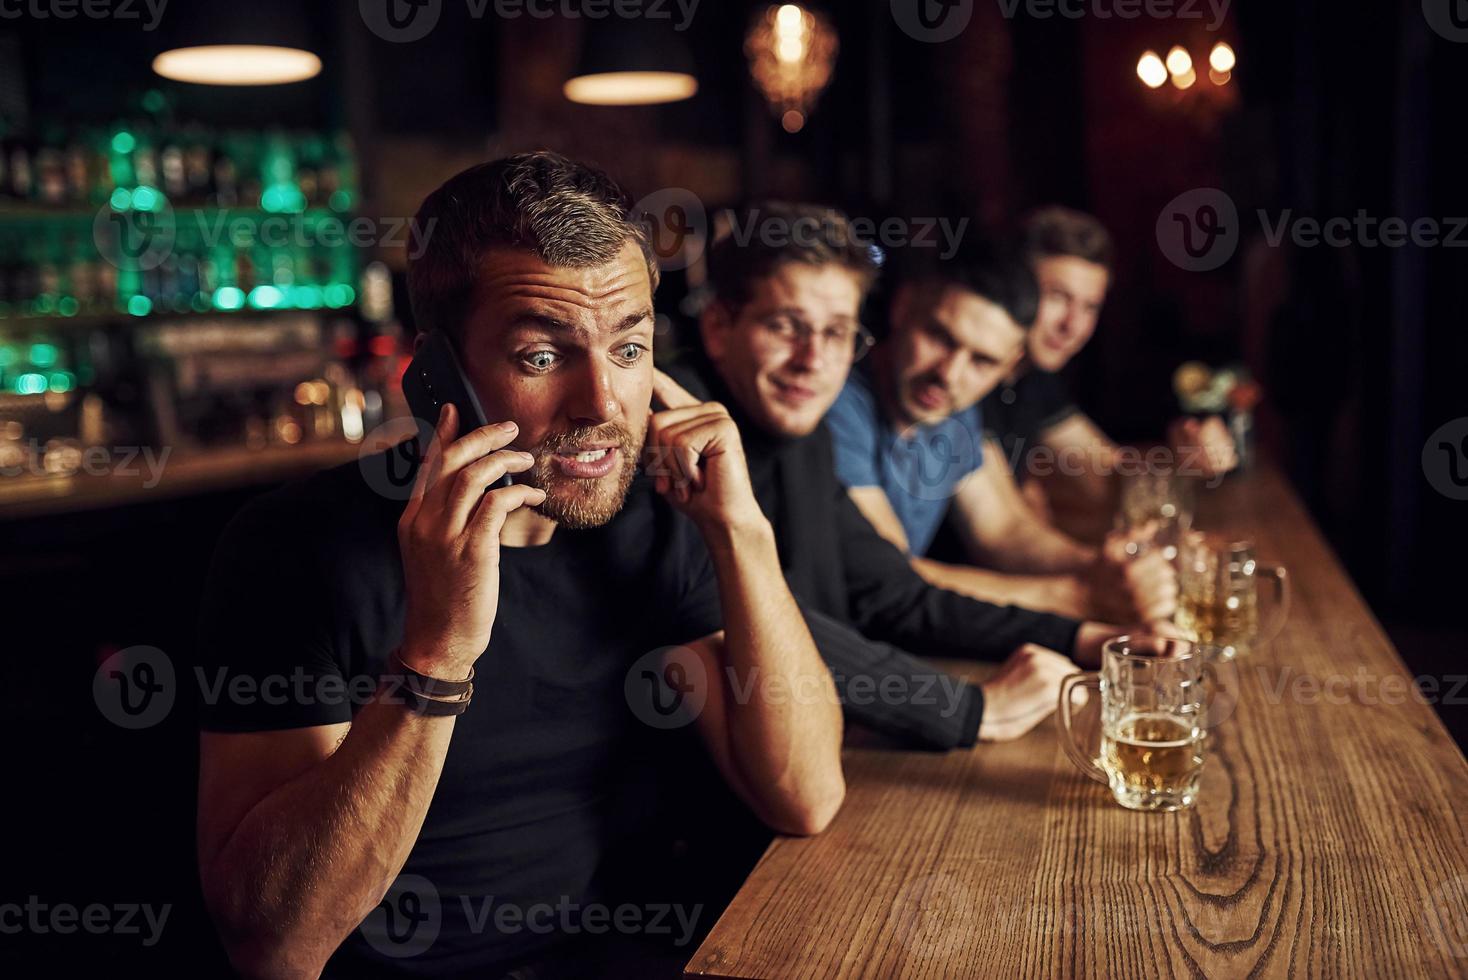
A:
825,367,984,556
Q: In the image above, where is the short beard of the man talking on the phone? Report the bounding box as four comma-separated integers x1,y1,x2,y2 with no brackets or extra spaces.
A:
515,423,646,531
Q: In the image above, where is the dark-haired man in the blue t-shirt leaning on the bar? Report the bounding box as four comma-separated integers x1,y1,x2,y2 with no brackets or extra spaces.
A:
826,246,1176,622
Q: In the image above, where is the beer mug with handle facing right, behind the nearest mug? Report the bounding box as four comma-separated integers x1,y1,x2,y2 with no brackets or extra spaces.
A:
1174,531,1289,657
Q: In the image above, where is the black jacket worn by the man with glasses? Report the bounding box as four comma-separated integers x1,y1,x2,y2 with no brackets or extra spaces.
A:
668,355,1079,748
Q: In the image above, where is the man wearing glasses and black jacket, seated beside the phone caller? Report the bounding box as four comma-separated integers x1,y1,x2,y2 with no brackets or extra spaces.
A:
669,204,1119,747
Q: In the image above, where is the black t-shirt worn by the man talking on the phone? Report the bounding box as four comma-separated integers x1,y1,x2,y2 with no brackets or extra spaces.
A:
200,453,722,976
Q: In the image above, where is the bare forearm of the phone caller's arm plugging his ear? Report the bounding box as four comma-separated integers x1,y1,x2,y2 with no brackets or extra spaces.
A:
705,519,846,832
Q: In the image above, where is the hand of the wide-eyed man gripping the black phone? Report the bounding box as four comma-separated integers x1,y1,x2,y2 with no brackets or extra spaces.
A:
398,403,545,679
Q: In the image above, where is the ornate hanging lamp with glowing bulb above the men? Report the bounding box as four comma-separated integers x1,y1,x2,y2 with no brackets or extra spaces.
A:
744,3,838,132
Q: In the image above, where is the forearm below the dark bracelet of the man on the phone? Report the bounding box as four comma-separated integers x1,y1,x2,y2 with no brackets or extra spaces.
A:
201,688,454,976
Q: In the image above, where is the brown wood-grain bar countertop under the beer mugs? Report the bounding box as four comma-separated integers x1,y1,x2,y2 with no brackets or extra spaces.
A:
687,469,1468,977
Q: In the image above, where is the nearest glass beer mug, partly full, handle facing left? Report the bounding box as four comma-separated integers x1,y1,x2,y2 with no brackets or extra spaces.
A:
1060,637,1218,810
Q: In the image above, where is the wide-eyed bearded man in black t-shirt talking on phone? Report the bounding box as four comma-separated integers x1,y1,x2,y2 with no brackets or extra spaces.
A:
198,153,844,977
